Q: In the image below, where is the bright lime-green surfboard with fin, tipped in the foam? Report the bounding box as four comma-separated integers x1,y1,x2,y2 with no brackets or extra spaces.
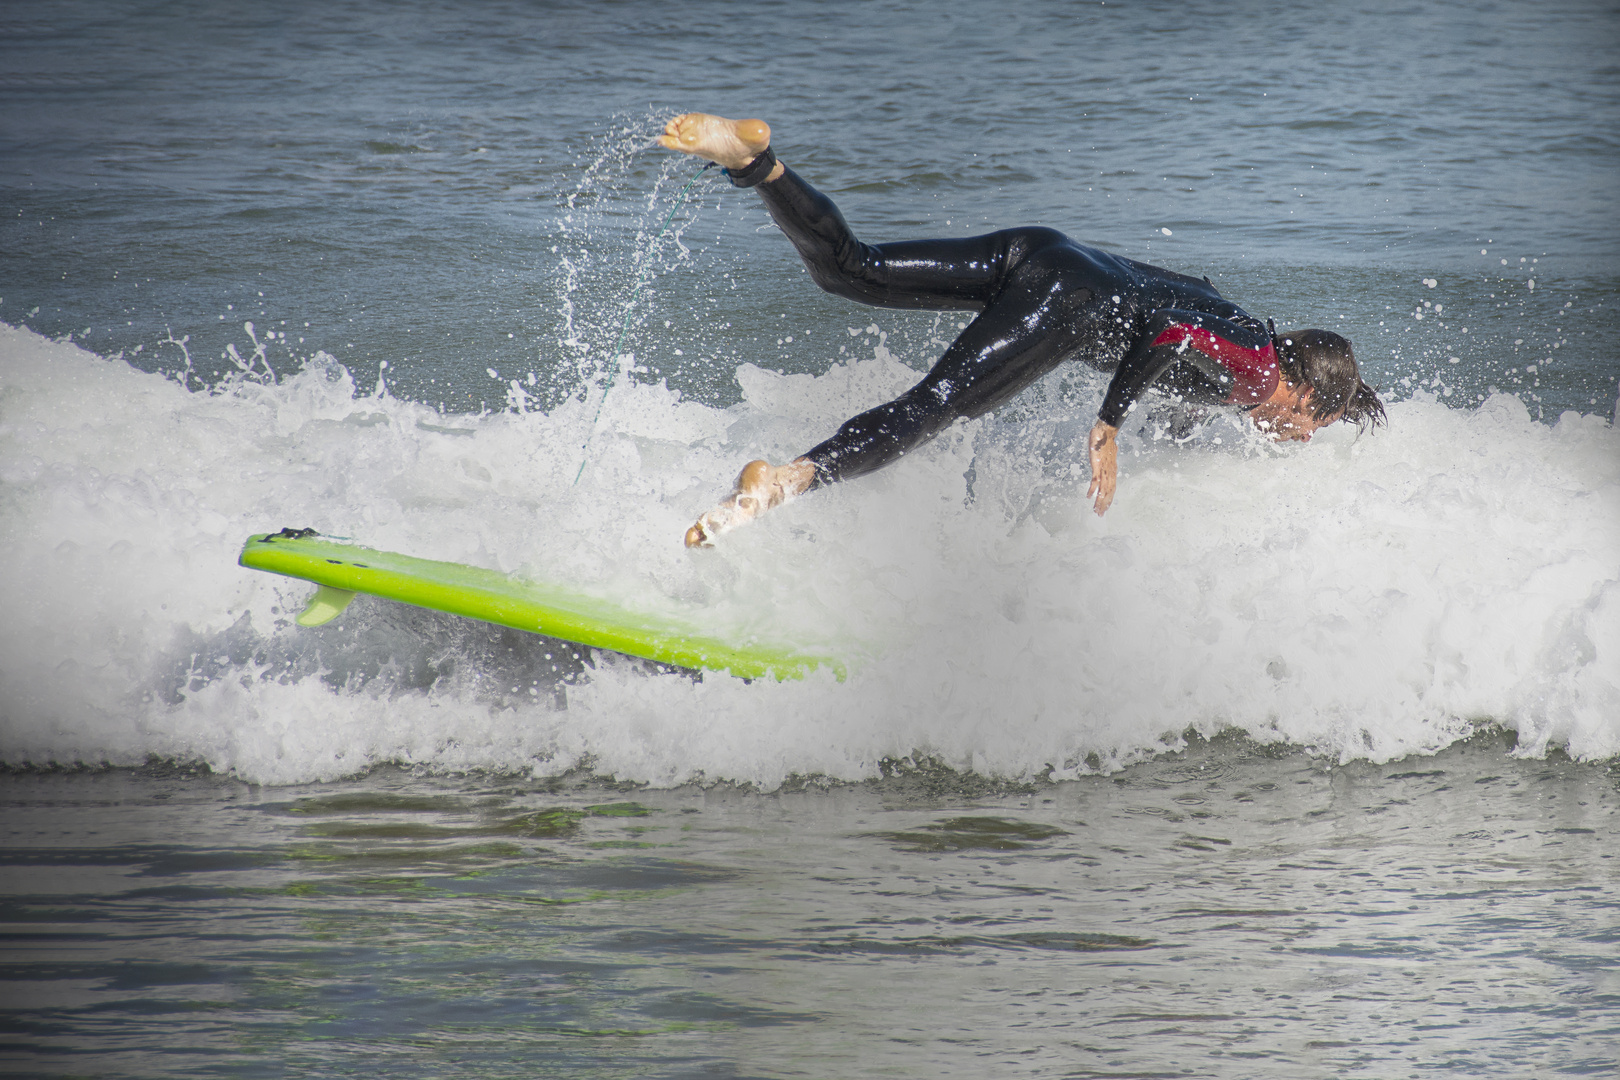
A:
238,529,846,680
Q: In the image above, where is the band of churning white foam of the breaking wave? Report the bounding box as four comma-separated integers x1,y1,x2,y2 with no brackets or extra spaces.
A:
0,320,1620,785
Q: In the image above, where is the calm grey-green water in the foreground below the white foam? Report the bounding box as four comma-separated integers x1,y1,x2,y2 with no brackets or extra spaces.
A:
3,737,1620,1077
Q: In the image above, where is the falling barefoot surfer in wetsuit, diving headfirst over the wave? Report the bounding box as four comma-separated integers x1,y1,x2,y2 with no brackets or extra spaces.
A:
658,113,1385,547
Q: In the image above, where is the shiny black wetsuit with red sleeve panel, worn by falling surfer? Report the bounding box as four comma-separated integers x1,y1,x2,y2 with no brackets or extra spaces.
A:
755,168,1278,486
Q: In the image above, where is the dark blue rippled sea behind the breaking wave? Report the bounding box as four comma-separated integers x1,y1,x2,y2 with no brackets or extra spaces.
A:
0,3,1620,416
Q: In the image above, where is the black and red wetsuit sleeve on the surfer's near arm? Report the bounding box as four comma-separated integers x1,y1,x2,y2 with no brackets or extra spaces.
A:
1097,308,1278,427
